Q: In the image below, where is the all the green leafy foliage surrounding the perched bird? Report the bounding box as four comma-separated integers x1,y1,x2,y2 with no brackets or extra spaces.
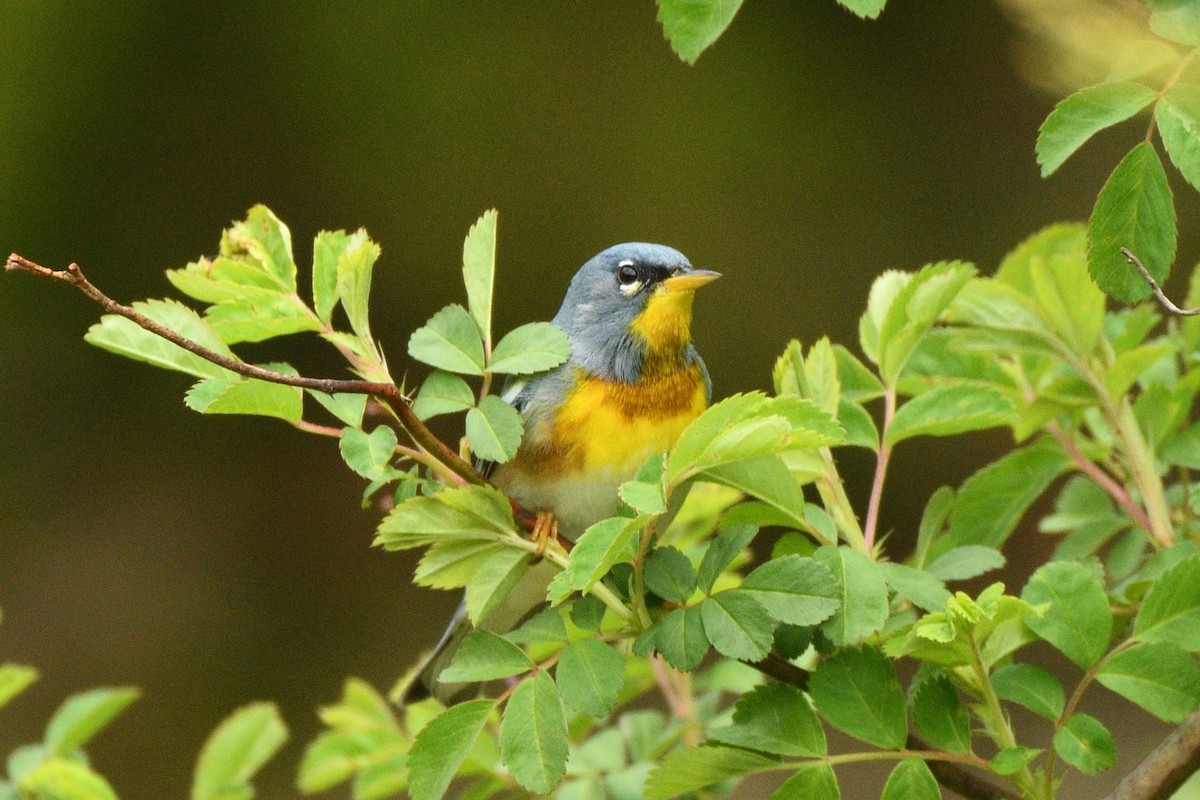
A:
7,0,1200,800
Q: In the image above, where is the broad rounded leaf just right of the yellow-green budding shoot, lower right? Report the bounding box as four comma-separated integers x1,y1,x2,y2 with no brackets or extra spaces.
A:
1021,561,1112,669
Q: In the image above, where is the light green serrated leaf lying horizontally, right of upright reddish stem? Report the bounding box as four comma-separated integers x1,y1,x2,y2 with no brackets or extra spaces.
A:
884,384,1015,445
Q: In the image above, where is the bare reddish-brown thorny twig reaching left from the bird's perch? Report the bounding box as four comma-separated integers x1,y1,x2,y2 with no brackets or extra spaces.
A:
5,253,536,530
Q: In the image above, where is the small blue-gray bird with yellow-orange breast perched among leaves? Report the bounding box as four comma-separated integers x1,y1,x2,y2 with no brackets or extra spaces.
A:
402,242,720,705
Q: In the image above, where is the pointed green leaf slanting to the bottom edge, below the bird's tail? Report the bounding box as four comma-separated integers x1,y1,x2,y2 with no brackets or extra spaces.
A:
408,700,496,800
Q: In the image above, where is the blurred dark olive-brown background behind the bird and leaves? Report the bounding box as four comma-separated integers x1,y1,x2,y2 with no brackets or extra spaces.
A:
0,0,1195,800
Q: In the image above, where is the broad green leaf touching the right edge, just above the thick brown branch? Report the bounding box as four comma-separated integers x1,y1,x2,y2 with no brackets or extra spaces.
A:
1096,642,1200,722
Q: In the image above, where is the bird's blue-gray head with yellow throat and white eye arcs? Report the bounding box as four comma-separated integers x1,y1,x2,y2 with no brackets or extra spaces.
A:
554,242,720,381
